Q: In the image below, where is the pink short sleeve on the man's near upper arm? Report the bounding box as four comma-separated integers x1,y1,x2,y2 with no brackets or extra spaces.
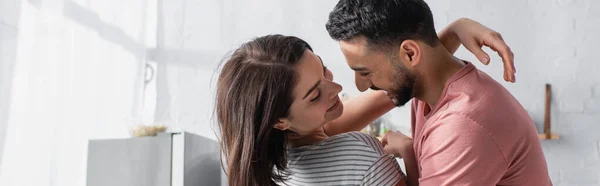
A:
419,114,507,186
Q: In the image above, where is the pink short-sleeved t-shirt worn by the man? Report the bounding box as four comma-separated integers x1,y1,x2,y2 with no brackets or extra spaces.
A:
411,63,552,186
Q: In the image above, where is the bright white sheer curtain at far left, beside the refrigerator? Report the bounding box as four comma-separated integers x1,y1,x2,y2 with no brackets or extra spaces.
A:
0,0,152,186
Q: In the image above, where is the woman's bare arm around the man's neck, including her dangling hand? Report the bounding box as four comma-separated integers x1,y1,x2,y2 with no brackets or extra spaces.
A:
324,18,514,136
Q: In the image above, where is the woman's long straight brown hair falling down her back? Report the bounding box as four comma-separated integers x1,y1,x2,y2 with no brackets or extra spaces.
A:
215,35,312,186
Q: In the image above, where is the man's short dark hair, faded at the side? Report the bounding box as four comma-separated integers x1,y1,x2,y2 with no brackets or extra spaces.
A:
325,0,439,50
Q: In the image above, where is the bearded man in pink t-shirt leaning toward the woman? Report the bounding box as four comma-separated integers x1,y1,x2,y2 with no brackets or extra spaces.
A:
326,0,552,186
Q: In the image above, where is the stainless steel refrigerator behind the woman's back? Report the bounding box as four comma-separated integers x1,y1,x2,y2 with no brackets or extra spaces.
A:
87,132,225,186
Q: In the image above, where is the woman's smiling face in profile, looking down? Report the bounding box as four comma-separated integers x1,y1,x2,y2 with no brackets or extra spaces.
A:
276,50,344,135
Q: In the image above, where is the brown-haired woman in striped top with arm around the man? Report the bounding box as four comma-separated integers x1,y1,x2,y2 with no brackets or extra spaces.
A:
216,19,512,186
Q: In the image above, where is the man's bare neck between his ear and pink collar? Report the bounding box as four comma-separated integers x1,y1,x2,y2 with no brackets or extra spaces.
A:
417,45,465,109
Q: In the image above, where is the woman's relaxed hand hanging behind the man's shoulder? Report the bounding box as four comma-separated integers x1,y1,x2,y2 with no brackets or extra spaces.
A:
439,18,516,83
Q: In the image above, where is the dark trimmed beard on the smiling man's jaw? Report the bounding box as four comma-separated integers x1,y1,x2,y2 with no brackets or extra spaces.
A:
389,65,417,107
